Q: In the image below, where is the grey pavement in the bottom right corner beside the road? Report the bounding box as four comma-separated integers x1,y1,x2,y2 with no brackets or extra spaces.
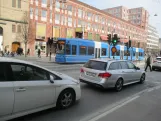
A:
97,88,161,121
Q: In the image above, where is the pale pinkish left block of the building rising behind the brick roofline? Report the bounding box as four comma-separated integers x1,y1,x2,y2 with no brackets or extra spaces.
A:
103,6,129,21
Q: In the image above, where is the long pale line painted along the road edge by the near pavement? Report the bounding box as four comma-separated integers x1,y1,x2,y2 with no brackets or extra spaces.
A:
88,96,140,121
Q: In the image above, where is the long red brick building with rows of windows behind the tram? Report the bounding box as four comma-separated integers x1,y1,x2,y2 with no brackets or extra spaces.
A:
29,0,147,54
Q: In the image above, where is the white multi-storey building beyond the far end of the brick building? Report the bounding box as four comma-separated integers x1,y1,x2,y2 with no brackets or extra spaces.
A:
147,25,159,54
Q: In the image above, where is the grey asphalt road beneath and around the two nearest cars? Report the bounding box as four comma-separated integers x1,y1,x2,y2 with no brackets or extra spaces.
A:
11,62,161,121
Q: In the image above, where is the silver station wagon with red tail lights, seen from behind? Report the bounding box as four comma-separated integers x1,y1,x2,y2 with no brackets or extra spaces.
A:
79,59,146,91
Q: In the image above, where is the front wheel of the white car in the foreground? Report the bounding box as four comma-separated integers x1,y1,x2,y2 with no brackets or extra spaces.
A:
57,89,75,109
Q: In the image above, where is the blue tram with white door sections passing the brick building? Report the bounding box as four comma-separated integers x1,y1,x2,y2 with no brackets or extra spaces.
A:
55,38,144,63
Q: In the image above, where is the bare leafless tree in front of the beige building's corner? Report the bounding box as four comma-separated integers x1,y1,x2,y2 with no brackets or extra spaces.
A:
18,12,29,57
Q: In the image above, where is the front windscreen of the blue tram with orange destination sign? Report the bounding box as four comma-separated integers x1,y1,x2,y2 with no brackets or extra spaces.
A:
56,41,65,54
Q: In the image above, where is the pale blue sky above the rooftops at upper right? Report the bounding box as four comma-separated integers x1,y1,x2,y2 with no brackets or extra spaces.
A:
80,0,161,38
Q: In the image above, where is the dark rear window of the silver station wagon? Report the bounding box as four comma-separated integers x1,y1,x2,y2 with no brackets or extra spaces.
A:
84,60,107,71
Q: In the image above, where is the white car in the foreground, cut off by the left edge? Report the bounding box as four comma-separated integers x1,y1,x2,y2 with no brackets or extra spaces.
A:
0,57,81,121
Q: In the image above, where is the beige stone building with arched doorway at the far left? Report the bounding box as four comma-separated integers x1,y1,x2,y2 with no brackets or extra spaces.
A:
0,0,29,52
